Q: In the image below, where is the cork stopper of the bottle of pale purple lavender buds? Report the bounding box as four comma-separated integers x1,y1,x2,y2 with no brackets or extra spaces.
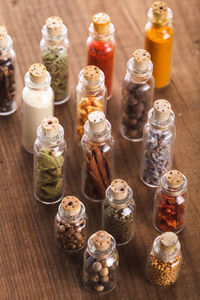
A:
153,99,171,122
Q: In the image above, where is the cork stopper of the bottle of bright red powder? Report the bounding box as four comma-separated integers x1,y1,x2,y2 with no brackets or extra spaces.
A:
92,12,110,34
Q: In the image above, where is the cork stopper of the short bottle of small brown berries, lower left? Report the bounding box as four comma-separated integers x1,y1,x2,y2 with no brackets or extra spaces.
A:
61,196,81,216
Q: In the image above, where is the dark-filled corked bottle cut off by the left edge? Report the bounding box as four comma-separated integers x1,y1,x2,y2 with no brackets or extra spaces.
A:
0,26,18,116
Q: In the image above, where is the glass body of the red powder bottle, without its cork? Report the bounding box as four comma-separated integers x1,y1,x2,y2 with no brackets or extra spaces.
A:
87,23,115,99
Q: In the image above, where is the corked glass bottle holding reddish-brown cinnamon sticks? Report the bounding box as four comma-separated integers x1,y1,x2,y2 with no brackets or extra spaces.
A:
81,111,114,202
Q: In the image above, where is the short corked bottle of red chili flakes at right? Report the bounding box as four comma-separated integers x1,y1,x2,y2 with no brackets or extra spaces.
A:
153,170,187,233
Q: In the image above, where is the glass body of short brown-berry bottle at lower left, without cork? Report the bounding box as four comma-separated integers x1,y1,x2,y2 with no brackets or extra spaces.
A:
54,203,88,252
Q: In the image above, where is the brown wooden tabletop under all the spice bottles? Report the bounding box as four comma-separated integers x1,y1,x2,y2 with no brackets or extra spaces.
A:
0,0,200,300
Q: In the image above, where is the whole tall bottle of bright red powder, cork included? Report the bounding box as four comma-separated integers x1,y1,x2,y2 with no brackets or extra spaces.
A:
87,13,115,100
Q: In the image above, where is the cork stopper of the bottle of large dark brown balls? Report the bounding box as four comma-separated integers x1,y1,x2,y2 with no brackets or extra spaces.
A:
133,49,151,71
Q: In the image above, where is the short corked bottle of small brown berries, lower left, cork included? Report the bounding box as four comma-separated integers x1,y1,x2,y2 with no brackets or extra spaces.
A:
55,196,88,252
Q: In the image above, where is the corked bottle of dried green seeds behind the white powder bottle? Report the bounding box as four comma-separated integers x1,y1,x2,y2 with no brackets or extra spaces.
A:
40,16,70,105
